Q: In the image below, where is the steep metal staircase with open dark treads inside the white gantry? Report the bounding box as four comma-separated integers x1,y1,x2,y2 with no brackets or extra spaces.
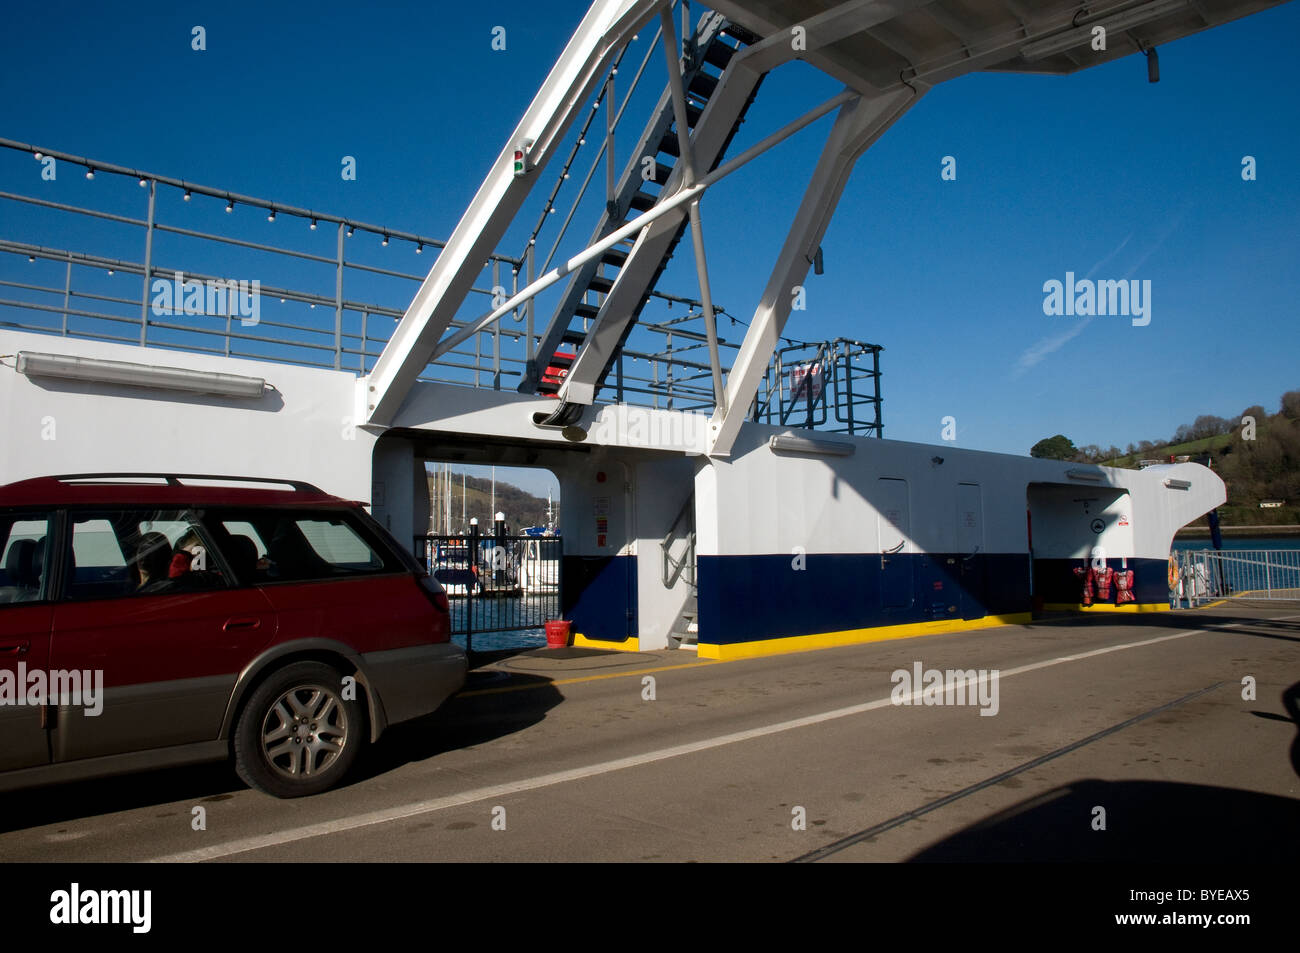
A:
519,13,758,395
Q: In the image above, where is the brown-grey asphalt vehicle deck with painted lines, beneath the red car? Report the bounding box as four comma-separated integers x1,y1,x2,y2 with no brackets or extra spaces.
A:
0,606,1300,862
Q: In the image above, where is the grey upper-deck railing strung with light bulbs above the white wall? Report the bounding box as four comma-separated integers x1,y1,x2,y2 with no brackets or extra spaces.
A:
0,115,879,432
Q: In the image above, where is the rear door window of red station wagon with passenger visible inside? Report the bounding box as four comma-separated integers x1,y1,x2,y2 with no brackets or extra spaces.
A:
68,508,228,601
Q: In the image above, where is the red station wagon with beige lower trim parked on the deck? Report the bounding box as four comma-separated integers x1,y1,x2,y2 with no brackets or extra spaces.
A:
0,473,467,797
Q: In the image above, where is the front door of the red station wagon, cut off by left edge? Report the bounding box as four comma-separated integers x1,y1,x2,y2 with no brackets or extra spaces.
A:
0,510,55,771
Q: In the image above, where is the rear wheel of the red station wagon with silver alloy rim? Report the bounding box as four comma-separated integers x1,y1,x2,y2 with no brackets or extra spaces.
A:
234,662,365,797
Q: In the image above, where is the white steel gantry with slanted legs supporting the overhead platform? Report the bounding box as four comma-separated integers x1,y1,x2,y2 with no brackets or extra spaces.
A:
358,0,1281,456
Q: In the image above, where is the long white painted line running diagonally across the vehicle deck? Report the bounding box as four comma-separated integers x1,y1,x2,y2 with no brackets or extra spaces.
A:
148,629,1209,863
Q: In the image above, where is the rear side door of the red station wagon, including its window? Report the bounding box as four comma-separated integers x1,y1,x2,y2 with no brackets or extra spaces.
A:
49,510,276,762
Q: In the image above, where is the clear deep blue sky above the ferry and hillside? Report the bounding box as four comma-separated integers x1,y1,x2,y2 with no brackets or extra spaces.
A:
0,0,1300,483
